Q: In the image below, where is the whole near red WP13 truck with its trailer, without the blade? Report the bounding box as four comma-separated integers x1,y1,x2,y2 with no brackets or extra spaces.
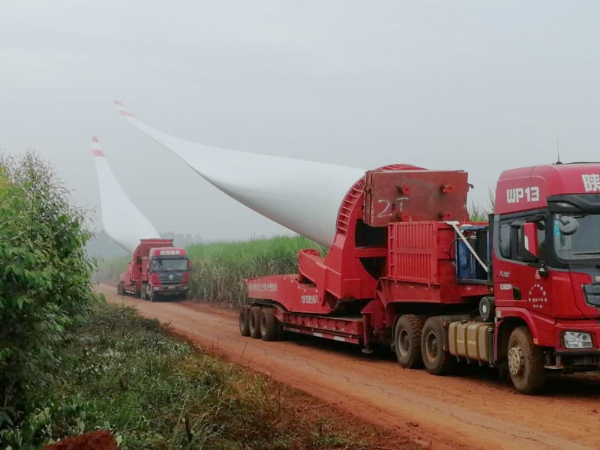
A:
239,163,600,394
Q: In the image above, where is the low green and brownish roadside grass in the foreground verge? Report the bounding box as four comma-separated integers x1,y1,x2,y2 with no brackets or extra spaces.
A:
0,303,396,450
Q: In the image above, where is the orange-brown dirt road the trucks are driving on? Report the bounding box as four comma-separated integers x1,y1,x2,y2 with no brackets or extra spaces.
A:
99,285,600,450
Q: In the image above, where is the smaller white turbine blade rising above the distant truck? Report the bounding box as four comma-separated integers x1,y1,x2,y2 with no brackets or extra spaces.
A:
92,136,160,253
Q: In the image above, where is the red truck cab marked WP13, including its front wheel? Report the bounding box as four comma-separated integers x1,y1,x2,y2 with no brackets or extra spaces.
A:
490,163,600,387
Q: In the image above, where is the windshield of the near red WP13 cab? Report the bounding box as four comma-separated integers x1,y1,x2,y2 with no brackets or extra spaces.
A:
553,214,600,261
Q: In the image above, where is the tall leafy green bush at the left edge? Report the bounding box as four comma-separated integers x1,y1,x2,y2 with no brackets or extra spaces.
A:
0,153,93,432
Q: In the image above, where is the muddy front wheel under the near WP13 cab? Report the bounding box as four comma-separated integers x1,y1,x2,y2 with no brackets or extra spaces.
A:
507,326,546,395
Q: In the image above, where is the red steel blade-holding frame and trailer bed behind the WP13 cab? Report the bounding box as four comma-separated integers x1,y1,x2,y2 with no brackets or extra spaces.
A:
245,165,488,345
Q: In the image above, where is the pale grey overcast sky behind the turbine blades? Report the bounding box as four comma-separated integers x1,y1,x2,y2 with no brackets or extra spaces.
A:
0,0,600,240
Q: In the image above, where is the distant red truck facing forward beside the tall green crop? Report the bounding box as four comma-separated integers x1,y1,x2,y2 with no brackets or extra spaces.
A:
117,239,191,302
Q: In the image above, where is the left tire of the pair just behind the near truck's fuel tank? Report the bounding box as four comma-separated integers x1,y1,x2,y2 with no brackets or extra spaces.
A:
394,314,423,369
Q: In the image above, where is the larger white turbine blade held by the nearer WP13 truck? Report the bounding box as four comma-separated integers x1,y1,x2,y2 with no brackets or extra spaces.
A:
115,101,365,246
